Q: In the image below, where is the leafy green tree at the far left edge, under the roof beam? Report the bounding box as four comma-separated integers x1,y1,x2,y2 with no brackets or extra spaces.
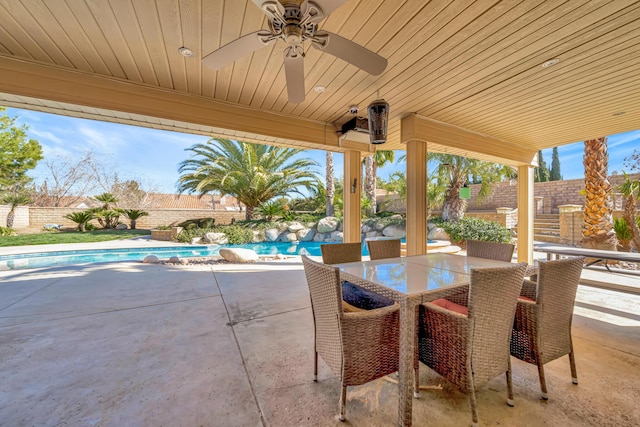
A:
0,107,42,194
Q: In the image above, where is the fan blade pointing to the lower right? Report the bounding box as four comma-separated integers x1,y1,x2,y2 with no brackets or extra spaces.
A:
311,31,387,76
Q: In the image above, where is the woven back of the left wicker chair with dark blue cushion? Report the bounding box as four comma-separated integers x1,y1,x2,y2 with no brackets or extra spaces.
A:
302,255,342,377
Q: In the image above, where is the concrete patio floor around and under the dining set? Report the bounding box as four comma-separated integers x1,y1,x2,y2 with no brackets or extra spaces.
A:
0,258,640,427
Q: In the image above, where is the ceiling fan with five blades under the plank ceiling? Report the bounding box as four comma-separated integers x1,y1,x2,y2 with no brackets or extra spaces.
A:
202,0,387,103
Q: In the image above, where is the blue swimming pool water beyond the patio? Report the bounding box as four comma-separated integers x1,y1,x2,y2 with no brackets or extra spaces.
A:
0,242,369,270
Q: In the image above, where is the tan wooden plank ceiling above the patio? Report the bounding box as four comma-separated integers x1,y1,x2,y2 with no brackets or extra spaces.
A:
0,0,640,160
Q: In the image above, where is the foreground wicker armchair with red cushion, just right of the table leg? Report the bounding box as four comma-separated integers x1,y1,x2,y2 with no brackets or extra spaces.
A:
415,263,527,426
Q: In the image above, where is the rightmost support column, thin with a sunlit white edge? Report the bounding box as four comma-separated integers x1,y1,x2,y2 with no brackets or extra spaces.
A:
518,165,534,264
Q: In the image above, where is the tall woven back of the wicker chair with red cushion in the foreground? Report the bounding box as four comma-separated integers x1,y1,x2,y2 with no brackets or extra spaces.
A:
468,263,527,387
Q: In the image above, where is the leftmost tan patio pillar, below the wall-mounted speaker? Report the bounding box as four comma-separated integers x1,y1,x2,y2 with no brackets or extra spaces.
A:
343,151,362,243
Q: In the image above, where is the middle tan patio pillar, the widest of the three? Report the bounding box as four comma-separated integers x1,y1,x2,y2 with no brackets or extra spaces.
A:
407,141,428,255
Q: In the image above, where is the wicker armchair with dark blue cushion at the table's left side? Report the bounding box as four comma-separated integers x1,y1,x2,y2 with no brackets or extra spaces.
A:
302,256,399,421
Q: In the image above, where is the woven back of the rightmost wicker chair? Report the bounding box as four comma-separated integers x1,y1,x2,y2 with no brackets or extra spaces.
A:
536,257,584,354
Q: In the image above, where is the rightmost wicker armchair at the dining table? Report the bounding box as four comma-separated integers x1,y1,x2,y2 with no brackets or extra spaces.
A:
511,257,584,400
